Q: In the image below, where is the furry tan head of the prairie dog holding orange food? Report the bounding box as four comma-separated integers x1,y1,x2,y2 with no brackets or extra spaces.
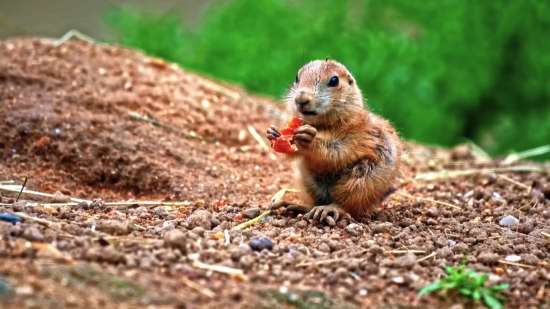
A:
287,59,363,123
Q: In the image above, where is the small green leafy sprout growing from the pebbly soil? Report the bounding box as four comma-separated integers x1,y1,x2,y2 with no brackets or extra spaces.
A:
418,259,510,309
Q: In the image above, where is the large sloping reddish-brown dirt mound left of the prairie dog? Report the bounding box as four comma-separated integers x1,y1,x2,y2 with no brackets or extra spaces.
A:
0,39,288,199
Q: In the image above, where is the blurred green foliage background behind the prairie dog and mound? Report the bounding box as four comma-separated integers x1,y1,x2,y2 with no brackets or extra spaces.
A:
0,0,550,160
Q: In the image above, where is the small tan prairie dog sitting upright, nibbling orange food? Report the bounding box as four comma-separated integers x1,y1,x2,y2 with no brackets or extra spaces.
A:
266,59,403,221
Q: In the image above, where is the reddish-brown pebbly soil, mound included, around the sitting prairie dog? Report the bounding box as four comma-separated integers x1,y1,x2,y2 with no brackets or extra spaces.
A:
0,38,550,308
